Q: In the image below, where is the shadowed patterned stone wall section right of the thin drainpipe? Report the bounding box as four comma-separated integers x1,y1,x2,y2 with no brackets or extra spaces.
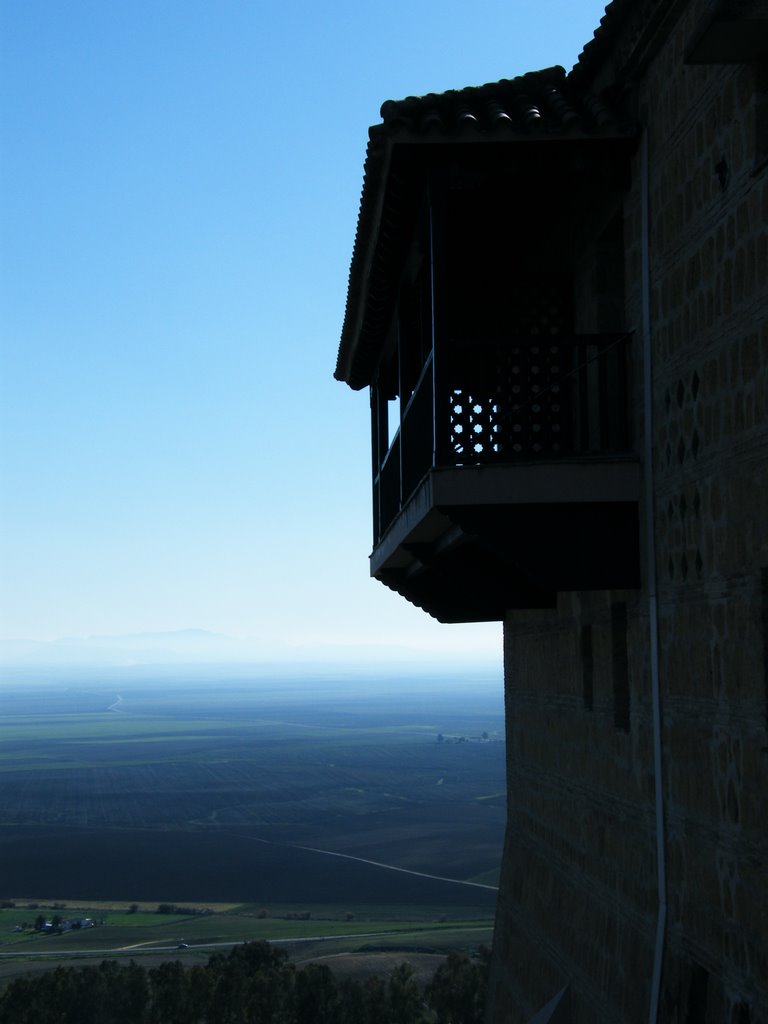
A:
644,18,768,1024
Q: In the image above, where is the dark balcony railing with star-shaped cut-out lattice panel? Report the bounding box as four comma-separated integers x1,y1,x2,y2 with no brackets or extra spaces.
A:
374,334,630,544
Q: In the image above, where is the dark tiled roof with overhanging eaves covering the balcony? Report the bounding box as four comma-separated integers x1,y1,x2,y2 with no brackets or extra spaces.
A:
335,62,636,390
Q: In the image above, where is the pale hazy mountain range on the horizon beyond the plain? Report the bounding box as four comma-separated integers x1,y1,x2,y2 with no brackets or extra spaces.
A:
0,629,501,669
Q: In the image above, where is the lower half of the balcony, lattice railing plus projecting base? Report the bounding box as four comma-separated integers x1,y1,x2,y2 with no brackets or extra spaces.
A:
371,335,639,622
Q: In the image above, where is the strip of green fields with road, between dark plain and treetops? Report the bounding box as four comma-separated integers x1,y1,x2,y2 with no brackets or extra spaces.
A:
0,901,493,991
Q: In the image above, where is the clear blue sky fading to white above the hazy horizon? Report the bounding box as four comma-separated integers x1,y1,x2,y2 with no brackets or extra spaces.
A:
0,0,604,657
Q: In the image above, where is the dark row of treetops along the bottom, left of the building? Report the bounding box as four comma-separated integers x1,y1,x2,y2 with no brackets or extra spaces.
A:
0,942,488,1024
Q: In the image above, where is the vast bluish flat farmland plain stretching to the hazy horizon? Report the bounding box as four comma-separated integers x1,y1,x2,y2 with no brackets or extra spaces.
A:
0,675,505,913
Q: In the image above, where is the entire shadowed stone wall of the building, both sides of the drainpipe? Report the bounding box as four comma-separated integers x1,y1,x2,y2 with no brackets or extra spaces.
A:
490,2,768,1024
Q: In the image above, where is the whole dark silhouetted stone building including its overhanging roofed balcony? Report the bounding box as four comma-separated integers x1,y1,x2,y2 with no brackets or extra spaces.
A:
336,0,768,1024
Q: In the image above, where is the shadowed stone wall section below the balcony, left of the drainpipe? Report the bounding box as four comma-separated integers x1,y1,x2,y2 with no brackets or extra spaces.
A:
495,593,655,1021
